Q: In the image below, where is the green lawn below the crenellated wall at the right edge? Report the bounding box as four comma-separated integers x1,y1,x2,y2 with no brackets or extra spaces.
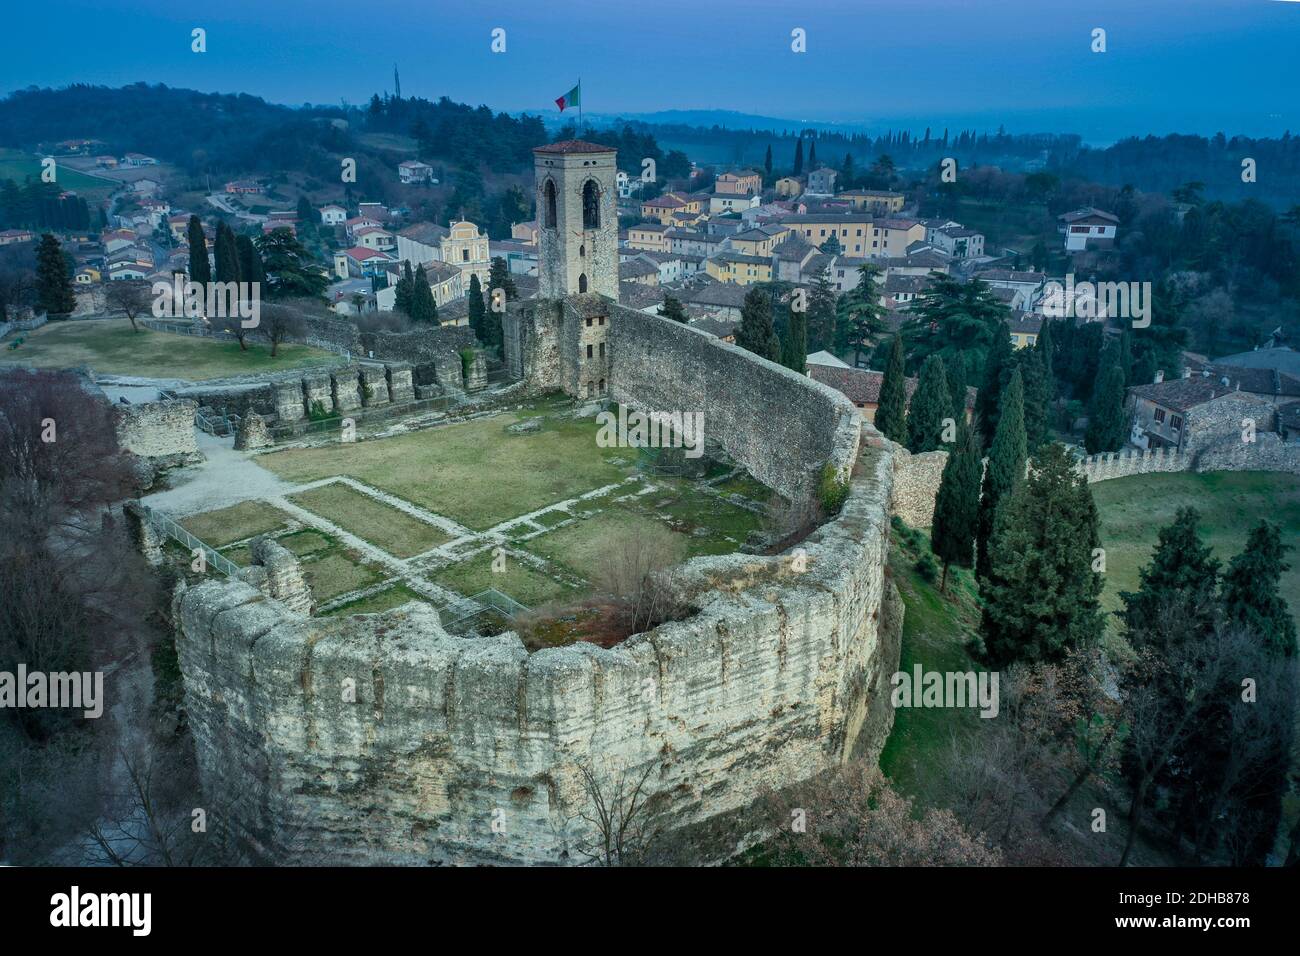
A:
1092,471,1300,627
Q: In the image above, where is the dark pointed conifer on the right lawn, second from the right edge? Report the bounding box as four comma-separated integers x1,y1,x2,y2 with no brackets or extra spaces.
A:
1119,507,1219,652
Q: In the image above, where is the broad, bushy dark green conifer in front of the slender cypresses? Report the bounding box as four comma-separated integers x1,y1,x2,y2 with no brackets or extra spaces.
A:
980,442,1104,666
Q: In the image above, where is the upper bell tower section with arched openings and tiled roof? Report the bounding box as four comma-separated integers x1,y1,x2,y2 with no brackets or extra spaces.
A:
533,139,619,302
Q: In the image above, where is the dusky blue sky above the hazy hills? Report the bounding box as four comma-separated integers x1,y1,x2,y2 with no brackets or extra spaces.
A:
0,0,1300,142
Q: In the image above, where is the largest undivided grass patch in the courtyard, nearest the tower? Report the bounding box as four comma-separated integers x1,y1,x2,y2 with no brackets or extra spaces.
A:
256,412,629,531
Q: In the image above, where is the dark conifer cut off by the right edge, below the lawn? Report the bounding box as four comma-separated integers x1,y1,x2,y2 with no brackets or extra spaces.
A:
1221,520,1296,657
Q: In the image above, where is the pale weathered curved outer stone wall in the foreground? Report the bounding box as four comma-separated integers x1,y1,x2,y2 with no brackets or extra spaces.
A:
173,434,897,864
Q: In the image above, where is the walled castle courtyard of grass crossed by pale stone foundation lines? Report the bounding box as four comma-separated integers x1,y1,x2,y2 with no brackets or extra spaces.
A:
154,397,768,640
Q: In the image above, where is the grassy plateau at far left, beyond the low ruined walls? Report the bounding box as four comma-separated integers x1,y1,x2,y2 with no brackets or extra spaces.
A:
0,319,338,381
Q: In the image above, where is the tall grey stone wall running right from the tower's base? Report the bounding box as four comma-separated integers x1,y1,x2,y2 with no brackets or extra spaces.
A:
610,304,861,498
